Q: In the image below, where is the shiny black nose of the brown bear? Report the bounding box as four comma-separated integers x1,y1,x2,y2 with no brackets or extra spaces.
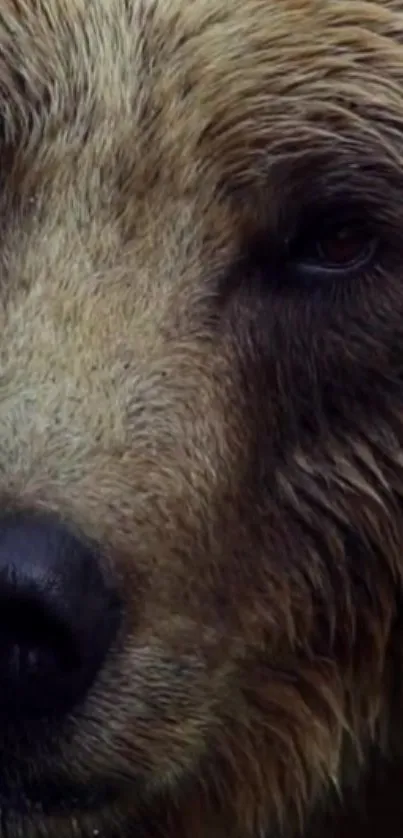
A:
0,514,119,722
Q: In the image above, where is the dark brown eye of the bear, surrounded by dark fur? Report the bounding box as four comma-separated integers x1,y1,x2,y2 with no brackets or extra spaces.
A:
289,212,379,277
